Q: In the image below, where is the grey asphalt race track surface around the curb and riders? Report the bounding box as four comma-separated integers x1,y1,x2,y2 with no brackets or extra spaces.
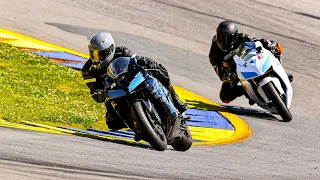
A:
0,0,320,179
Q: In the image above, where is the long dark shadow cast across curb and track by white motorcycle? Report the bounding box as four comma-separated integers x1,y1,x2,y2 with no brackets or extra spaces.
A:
187,100,279,121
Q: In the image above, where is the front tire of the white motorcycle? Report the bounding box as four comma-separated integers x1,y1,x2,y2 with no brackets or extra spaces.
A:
262,82,292,122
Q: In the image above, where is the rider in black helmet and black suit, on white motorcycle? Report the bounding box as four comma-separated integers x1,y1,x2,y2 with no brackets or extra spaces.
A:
209,21,293,105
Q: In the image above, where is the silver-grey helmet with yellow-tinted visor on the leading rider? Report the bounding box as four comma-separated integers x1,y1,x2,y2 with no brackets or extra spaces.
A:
88,32,115,65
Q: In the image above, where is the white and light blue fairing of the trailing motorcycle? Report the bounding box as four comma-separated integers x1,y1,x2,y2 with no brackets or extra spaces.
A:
233,41,293,108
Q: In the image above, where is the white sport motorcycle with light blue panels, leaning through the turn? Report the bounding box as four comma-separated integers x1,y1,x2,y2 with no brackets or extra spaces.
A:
233,41,293,122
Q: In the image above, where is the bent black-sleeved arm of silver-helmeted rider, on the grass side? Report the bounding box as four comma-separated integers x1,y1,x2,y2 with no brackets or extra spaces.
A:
81,60,106,103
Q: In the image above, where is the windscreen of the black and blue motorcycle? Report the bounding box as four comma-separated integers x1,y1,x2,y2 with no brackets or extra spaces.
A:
107,57,130,79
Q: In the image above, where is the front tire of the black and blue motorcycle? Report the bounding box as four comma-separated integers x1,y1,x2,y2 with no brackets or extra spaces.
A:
131,101,167,151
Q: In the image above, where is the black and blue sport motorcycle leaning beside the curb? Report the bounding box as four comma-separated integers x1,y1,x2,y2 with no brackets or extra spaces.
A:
106,57,192,151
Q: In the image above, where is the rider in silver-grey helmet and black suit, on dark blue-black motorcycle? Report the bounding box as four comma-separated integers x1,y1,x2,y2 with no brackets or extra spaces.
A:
82,32,187,142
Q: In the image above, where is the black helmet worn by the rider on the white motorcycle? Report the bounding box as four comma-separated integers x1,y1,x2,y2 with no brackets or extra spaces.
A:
216,21,238,51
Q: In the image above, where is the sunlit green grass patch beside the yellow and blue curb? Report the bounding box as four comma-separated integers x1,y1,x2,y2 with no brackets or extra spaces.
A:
0,43,105,128
